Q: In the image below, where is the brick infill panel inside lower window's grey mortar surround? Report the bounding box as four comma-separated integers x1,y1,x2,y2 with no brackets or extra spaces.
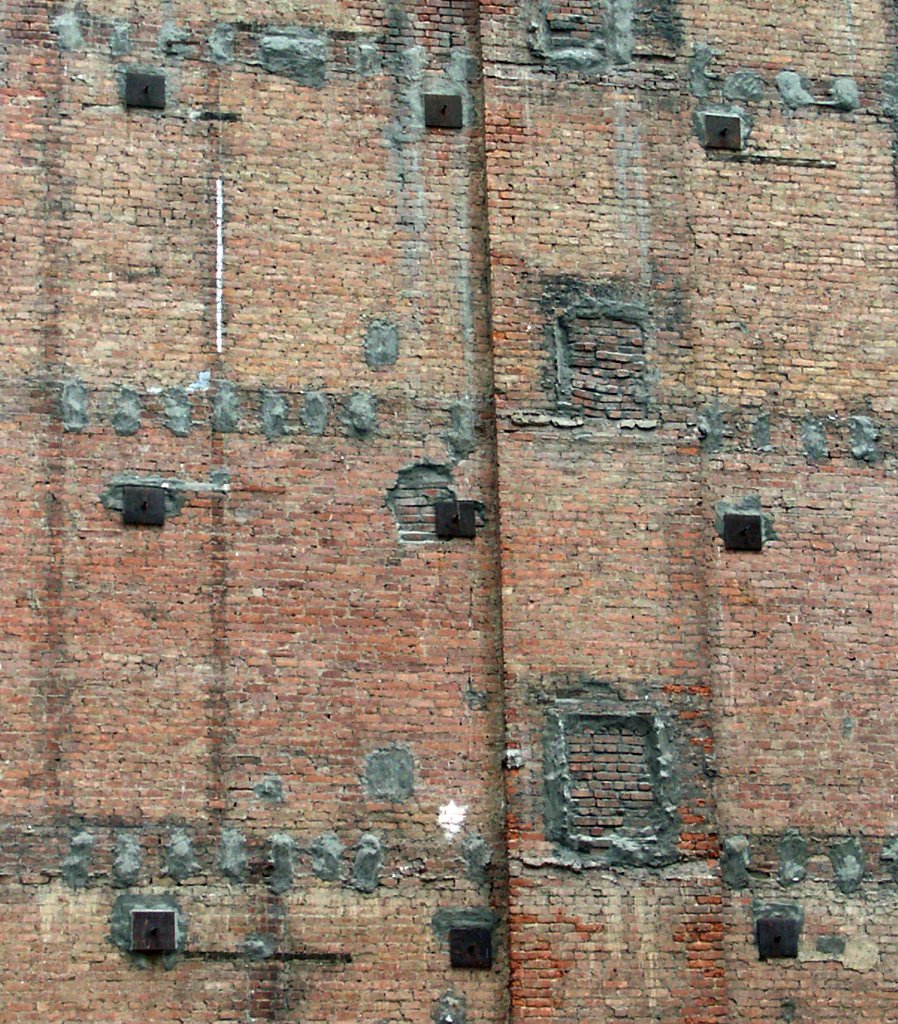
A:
567,723,654,845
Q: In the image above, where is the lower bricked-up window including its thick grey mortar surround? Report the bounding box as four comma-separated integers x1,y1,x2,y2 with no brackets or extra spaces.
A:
544,700,679,865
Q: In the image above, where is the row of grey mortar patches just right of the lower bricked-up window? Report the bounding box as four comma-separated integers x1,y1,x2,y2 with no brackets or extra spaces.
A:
721,828,898,893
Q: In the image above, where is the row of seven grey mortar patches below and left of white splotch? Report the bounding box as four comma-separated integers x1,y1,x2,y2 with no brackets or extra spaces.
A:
58,828,384,894
